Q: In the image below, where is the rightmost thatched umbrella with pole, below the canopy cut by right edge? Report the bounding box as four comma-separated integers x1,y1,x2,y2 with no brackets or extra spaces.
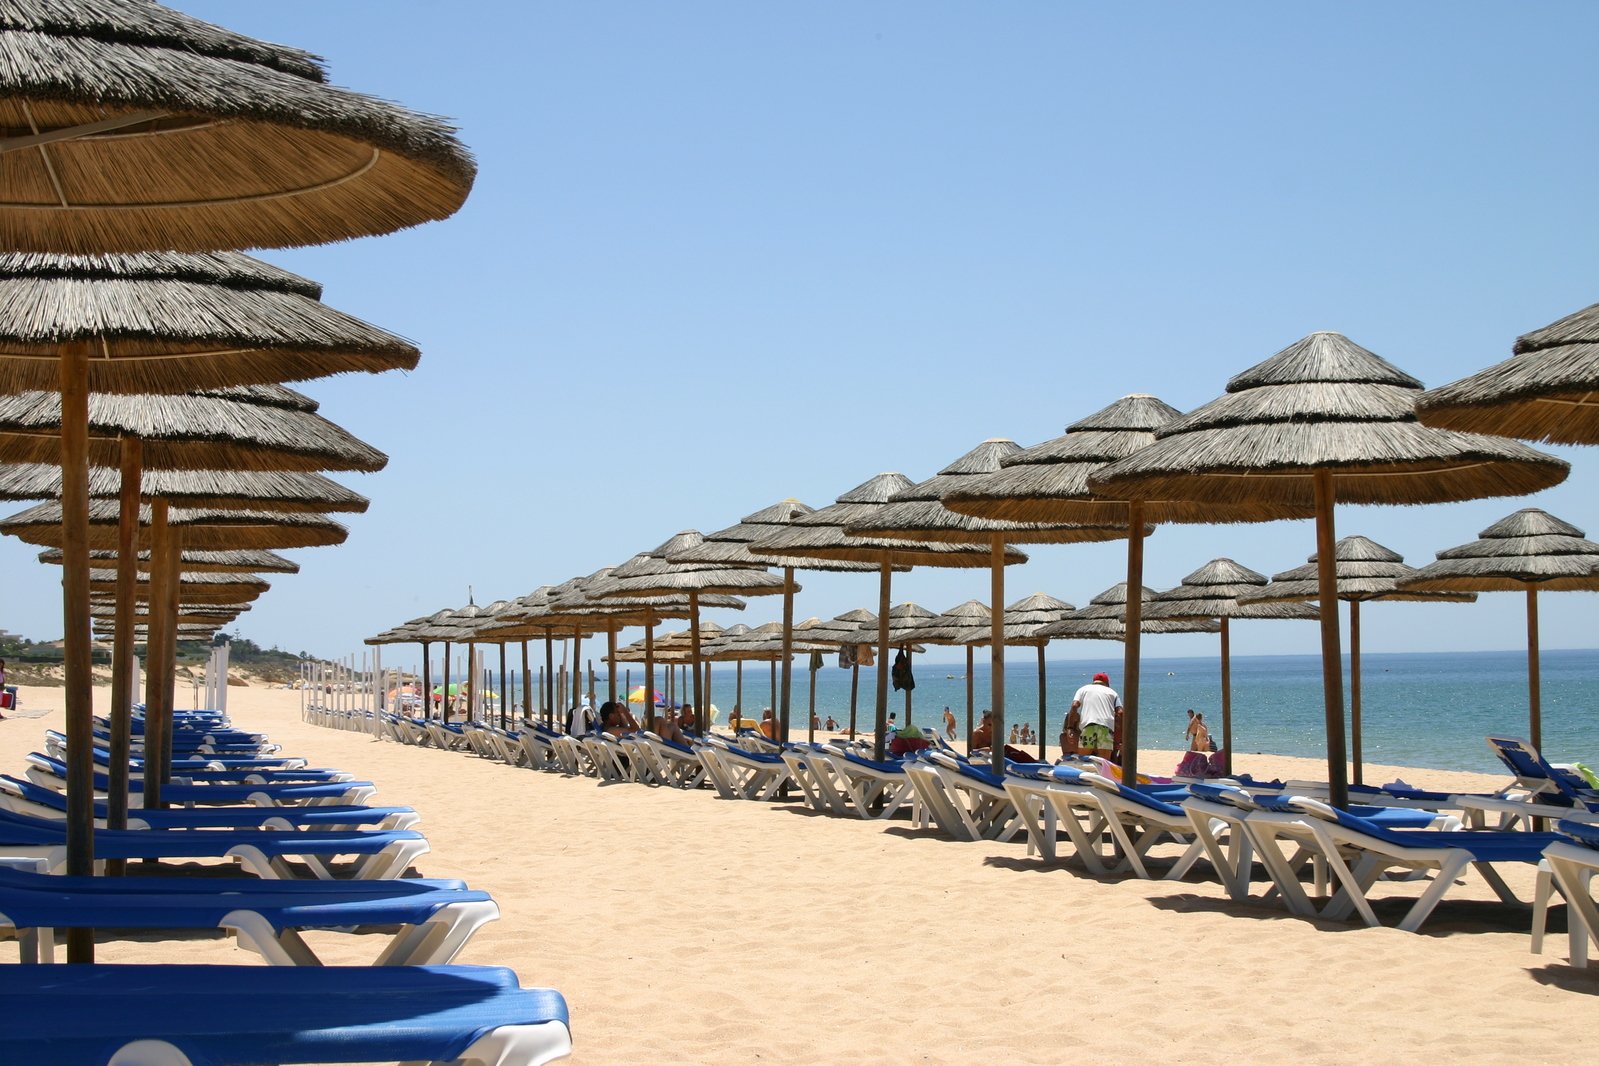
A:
1399,507,1599,748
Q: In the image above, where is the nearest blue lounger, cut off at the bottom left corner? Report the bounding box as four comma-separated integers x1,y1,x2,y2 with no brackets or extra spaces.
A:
0,964,572,1066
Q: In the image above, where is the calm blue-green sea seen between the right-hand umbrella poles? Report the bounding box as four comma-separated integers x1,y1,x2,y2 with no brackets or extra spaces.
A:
473,649,1599,772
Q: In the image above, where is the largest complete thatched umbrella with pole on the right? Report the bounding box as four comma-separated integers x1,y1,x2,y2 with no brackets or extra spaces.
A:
1089,332,1569,805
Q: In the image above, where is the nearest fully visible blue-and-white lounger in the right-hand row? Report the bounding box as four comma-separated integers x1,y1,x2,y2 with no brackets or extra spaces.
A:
1247,796,1557,932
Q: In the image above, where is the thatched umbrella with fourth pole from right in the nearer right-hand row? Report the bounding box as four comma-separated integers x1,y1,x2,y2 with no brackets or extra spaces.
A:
750,473,1027,759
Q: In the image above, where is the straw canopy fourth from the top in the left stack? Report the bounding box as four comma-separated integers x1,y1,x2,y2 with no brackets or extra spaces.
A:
0,463,368,515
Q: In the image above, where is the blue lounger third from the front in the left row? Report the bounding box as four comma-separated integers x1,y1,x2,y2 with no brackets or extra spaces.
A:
0,810,429,881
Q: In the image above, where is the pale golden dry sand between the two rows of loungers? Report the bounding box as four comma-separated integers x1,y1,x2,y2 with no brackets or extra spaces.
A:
0,689,1599,1064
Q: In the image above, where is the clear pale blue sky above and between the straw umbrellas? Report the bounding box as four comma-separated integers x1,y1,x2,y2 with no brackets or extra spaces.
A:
0,0,1599,665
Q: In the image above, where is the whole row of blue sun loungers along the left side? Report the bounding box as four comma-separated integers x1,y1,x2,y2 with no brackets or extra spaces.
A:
0,711,571,1066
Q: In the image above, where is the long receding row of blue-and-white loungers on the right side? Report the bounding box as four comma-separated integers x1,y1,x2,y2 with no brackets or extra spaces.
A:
321,713,1599,965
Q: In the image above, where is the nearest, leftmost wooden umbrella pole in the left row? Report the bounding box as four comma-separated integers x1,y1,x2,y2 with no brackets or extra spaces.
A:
61,340,94,962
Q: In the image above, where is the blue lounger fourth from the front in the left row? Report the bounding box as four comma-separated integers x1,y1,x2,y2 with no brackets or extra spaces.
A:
0,774,422,829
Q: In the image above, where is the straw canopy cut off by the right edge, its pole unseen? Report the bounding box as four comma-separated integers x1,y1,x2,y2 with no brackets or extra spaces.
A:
1415,304,1599,444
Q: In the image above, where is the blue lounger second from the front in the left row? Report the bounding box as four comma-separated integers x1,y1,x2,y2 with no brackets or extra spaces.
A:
0,868,499,965
